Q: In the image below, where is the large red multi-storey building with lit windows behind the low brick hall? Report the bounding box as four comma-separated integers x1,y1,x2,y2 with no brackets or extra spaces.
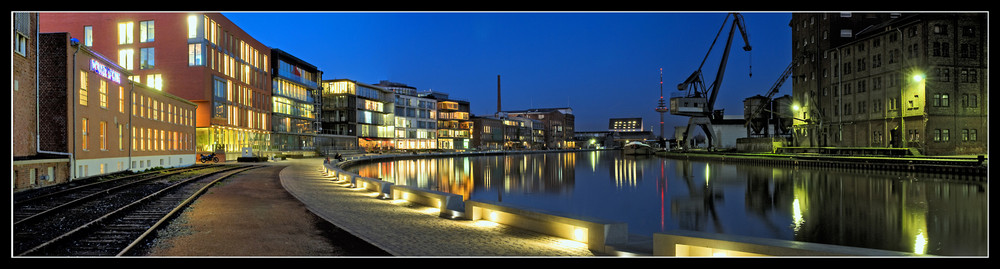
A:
40,12,273,160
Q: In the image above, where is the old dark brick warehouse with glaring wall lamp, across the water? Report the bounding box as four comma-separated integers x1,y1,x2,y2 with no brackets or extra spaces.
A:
789,13,989,155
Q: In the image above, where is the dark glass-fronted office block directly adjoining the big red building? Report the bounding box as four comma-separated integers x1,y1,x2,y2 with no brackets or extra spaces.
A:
264,49,323,156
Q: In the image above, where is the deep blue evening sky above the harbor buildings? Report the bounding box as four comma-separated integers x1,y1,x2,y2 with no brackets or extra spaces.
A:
223,12,792,136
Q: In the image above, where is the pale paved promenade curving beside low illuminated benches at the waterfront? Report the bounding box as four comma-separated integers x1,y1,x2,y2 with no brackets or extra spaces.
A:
280,158,595,257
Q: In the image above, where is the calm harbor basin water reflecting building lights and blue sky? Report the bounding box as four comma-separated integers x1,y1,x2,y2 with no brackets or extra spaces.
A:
351,151,989,256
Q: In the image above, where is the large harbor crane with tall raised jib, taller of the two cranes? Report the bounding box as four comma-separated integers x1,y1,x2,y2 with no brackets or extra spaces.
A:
670,13,753,149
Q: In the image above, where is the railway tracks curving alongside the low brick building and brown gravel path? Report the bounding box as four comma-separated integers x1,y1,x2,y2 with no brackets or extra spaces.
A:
13,163,260,256
